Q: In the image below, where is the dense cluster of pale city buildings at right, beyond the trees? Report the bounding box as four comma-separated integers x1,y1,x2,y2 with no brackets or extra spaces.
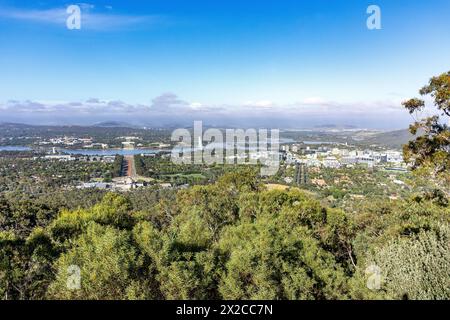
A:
281,145,405,168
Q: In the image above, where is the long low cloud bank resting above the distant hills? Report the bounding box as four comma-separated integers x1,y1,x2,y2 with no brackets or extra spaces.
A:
0,93,411,129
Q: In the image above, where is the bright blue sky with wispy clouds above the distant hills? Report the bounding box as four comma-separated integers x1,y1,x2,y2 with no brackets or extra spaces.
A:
0,0,450,127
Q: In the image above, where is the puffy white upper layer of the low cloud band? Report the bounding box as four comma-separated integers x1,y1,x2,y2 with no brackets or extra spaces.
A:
0,93,404,115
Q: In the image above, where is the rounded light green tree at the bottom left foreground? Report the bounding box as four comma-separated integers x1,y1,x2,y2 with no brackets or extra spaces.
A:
48,222,141,299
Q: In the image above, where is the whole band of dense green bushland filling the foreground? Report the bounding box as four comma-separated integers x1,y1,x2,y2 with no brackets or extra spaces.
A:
0,168,450,299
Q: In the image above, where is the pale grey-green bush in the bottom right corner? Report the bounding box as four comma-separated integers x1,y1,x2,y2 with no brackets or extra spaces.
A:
354,225,450,300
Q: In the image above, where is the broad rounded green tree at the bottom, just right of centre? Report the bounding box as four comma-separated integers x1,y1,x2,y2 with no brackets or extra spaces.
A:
218,218,346,299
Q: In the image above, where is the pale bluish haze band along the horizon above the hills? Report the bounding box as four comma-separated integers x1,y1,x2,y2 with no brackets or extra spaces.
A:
0,95,411,130
